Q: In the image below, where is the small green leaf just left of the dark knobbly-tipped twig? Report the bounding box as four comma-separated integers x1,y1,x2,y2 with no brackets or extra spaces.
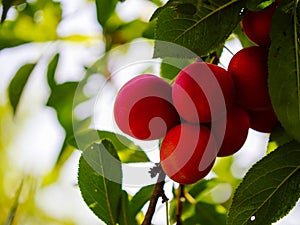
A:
130,185,154,217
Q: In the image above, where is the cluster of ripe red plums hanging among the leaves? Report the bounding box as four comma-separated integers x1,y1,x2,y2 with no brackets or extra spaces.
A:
114,2,278,184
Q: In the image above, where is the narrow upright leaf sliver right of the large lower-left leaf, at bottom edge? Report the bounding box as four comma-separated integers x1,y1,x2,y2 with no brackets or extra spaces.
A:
119,191,137,225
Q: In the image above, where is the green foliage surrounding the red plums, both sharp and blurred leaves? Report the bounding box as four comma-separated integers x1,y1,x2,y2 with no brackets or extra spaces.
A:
0,0,300,225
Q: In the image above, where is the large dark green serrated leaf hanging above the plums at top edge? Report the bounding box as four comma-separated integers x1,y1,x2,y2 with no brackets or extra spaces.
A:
154,0,245,57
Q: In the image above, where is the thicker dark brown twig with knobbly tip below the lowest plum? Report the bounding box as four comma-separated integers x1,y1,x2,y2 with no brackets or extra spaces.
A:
142,164,169,225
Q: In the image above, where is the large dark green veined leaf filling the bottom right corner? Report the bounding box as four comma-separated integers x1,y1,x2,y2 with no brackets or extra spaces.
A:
227,142,300,225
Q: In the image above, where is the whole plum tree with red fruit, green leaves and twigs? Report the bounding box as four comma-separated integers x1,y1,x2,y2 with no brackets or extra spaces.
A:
0,0,300,225
